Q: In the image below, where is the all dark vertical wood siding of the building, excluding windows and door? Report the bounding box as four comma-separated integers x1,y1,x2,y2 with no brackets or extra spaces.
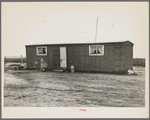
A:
26,44,133,72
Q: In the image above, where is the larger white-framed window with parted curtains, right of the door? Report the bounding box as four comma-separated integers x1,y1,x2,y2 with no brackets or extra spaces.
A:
89,45,104,56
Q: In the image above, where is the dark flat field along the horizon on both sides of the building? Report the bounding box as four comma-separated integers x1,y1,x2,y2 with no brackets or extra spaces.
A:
4,58,145,66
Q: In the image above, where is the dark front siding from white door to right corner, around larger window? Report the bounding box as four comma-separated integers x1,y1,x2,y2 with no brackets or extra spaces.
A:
68,45,119,72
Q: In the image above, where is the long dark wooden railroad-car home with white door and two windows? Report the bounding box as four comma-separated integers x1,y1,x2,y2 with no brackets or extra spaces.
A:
26,41,133,72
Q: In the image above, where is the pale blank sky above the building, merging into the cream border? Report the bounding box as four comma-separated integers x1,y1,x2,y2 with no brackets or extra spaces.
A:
1,2,149,58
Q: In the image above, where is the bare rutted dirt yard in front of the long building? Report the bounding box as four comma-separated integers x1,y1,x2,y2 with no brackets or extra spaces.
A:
4,67,145,107
